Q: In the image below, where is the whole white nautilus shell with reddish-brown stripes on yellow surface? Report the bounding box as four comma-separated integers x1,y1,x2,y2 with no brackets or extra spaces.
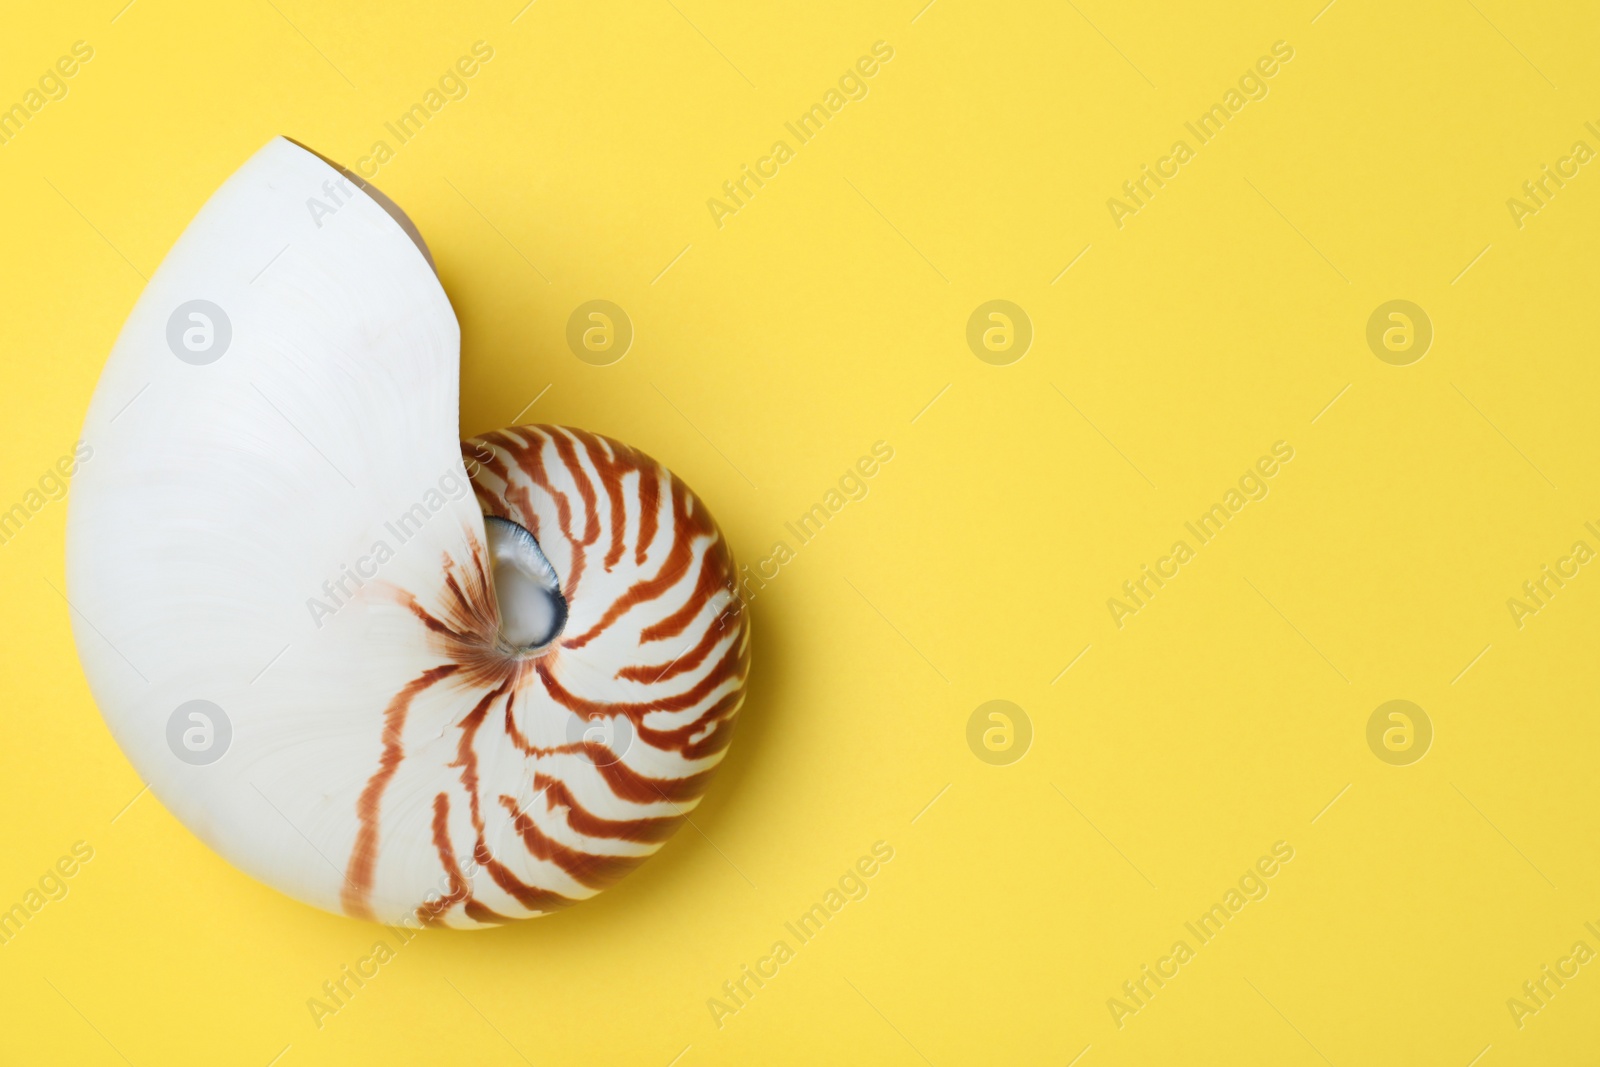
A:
67,139,750,926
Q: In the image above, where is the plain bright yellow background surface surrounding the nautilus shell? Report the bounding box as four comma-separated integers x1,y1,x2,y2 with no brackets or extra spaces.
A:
0,0,1600,1067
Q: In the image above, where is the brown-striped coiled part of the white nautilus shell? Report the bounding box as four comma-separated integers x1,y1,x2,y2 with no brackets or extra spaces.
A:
342,426,750,926
